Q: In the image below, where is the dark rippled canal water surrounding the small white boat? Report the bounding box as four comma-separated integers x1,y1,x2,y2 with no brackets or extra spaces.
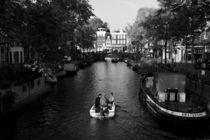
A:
0,62,210,140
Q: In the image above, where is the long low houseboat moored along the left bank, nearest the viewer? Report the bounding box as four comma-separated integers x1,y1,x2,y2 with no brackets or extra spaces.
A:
0,76,50,116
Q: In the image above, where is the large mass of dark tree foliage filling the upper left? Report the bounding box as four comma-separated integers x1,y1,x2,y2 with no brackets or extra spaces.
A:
0,0,94,59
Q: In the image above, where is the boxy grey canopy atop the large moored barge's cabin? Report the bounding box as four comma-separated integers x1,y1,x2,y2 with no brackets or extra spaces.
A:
155,73,186,92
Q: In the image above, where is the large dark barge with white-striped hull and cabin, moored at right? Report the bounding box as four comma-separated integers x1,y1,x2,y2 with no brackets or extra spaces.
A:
139,72,209,124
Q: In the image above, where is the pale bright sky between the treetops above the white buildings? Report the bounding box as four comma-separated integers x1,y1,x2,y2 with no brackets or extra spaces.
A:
89,0,158,30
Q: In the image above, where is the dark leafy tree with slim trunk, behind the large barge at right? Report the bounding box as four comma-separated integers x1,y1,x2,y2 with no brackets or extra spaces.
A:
156,0,210,63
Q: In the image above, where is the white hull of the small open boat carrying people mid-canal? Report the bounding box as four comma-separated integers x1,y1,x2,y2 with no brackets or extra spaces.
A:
90,103,115,119
